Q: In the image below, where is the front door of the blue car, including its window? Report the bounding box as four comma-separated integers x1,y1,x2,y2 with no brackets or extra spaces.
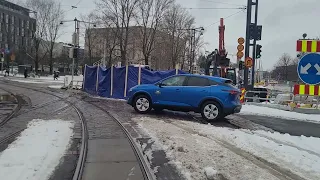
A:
153,76,186,106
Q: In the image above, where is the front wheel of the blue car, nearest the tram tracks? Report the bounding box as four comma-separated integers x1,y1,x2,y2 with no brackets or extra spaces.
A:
133,95,152,114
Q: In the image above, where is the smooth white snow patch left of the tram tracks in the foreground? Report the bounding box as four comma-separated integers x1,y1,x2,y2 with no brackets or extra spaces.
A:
0,120,73,180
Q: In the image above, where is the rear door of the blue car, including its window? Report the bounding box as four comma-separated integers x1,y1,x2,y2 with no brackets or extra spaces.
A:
181,76,211,107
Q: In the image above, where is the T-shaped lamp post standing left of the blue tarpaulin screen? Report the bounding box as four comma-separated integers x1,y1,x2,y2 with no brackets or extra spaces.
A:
60,18,96,87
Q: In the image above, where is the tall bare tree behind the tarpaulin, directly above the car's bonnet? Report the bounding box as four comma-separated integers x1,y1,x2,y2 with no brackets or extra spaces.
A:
136,0,173,65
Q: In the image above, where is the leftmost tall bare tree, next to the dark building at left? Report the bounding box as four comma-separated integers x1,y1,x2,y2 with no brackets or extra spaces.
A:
26,0,51,73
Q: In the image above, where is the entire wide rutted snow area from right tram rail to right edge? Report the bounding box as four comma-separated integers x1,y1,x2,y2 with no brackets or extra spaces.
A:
134,117,320,180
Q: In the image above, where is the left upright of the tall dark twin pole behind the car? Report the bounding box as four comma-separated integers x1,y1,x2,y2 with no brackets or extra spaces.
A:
243,0,252,89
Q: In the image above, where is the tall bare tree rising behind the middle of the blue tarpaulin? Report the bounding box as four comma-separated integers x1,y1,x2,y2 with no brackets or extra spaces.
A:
97,0,139,64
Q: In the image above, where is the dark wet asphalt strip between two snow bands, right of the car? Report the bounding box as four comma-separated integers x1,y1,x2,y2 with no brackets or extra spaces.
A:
239,115,320,137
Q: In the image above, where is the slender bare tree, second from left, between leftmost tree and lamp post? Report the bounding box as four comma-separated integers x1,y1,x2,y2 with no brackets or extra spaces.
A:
45,0,63,74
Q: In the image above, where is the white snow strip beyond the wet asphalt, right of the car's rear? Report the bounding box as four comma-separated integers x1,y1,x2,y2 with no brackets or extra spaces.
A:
240,104,320,123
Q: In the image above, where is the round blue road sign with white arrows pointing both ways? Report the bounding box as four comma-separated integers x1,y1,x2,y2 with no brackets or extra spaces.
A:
297,53,320,85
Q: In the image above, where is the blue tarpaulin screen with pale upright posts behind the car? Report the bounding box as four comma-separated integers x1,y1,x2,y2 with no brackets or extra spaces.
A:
83,66,185,99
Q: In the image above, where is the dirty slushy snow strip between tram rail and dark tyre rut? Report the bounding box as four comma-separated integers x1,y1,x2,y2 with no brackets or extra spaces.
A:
134,117,277,180
